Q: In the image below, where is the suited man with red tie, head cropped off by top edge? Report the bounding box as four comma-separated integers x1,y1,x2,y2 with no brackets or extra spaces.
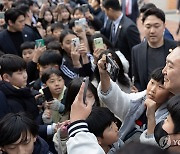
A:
121,0,139,23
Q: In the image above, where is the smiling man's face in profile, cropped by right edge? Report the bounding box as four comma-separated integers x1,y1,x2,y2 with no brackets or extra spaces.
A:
162,47,180,94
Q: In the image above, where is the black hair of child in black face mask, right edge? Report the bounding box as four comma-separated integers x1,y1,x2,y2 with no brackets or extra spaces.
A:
167,95,180,134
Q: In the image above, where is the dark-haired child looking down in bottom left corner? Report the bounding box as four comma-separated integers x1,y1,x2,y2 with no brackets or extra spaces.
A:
0,113,50,154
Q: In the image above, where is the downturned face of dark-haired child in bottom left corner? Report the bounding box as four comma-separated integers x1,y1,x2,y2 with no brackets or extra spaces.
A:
2,132,36,154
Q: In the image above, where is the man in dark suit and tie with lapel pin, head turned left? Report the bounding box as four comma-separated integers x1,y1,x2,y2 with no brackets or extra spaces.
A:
103,0,140,77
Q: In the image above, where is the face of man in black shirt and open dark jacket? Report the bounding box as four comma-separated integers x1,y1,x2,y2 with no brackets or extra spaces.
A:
144,15,165,45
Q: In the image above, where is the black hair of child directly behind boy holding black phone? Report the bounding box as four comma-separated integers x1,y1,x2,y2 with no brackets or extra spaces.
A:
38,50,62,66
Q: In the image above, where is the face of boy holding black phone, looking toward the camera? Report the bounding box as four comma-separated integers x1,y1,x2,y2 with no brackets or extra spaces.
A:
46,74,64,97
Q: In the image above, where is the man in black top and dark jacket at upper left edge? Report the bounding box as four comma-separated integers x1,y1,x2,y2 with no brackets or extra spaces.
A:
0,8,25,56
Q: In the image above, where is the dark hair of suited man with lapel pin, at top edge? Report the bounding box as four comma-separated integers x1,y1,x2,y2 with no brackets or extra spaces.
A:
102,0,122,11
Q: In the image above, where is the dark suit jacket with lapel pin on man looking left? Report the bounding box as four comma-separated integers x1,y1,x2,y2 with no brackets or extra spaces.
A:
101,15,141,77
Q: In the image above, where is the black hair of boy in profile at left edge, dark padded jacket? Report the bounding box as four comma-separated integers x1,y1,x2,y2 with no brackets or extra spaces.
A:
0,54,26,76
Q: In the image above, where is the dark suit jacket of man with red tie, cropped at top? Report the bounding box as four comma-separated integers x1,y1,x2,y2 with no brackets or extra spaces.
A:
121,0,139,23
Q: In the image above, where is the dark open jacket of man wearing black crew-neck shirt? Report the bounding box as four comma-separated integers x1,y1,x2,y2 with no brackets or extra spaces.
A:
132,39,176,91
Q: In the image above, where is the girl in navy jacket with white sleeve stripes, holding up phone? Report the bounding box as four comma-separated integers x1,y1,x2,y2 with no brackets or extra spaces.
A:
59,30,92,85
